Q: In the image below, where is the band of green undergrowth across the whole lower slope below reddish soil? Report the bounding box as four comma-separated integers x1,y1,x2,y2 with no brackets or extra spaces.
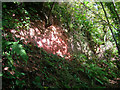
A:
3,39,119,88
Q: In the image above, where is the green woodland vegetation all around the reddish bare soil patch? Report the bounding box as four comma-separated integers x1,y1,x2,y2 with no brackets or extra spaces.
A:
2,2,120,89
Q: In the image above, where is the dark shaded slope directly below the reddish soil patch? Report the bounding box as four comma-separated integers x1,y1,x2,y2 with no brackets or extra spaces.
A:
3,39,102,88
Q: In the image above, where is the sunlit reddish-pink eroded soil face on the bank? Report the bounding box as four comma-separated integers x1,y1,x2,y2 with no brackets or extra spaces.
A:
10,20,70,59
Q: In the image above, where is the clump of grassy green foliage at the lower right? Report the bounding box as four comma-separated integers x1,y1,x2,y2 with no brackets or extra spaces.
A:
76,54,118,86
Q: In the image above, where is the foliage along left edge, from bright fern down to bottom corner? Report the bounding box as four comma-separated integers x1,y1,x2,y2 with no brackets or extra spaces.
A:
2,39,28,88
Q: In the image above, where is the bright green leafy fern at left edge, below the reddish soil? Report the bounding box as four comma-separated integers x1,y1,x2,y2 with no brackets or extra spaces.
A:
2,39,28,64
